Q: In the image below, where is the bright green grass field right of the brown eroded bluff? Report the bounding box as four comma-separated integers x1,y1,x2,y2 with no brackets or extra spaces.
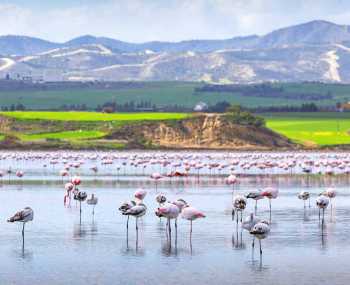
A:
264,113,350,146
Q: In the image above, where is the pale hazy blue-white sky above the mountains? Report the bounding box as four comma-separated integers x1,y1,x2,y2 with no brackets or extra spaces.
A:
0,0,350,42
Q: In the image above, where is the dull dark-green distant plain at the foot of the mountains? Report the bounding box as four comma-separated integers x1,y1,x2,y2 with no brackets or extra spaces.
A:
0,82,350,110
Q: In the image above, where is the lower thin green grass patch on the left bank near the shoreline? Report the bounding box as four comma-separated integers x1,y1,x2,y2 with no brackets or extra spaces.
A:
18,130,106,141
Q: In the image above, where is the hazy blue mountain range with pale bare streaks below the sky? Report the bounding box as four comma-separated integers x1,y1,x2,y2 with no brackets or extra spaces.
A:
0,20,350,83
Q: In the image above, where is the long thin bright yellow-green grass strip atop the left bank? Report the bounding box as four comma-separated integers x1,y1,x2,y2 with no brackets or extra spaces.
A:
0,111,190,122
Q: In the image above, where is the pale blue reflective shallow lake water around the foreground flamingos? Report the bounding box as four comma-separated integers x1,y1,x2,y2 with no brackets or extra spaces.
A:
0,150,350,284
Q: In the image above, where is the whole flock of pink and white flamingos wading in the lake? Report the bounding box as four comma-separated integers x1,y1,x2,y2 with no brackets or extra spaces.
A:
0,152,344,256
